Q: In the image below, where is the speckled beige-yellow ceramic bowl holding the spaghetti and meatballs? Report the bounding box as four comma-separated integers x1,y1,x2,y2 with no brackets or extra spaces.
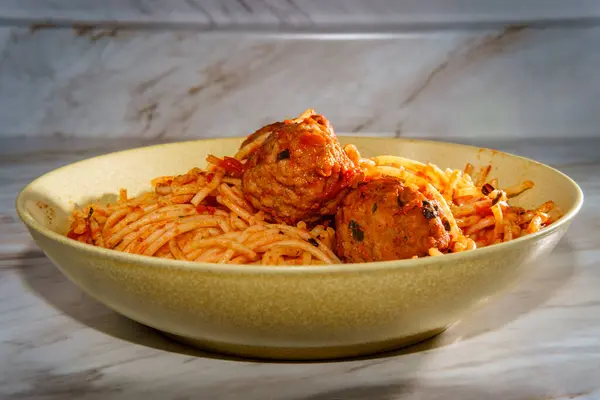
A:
17,137,583,359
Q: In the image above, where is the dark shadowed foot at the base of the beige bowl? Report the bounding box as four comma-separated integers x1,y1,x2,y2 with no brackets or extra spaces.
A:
162,327,447,361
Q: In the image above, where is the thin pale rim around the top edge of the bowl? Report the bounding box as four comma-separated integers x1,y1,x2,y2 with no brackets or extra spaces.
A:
15,134,584,274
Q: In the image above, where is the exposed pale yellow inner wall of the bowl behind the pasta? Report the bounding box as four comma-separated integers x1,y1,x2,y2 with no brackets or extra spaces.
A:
17,136,582,244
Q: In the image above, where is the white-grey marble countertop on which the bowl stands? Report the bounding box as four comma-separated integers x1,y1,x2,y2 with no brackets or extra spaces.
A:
0,138,600,400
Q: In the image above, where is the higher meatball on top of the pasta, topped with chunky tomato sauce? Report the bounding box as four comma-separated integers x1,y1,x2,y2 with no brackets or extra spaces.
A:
242,112,363,225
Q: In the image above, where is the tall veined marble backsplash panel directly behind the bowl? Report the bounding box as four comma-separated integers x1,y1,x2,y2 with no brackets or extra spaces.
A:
0,24,600,138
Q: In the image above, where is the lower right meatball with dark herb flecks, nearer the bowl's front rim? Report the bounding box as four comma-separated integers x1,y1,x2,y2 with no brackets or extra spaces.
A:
335,177,450,263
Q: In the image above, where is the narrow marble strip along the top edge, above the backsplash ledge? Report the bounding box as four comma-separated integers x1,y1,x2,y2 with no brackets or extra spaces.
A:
0,0,600,28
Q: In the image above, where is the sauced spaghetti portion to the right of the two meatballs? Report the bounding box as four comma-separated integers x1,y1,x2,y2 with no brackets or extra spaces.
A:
360,146,561,255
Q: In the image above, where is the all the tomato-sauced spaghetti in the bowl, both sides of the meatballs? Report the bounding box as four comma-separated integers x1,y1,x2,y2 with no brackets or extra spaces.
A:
67,141,560,265
